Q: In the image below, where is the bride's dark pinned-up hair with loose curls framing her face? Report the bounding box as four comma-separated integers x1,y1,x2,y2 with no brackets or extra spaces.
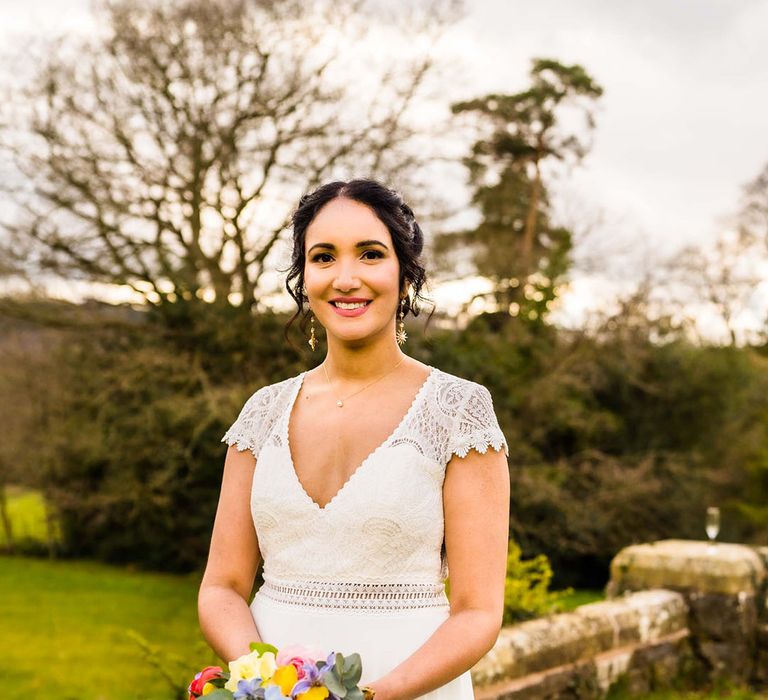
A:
284,179,434,343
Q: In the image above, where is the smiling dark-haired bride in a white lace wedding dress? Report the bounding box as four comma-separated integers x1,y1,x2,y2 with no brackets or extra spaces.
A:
198,180,509,700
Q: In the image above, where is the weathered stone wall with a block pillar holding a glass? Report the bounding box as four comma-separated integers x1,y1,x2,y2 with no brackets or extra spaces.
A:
472,540,768,700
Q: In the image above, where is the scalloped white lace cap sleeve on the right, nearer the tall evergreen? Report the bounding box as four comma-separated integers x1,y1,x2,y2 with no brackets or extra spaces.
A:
446,382,509,461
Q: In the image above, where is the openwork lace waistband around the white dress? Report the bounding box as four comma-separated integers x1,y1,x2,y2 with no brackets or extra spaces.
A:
258,577,448,610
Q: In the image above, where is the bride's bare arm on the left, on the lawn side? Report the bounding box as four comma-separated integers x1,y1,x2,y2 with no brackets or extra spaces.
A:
197,446,261,663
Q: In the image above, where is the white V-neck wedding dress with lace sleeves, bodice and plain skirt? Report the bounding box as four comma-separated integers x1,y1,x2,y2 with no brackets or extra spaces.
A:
222,367,509,700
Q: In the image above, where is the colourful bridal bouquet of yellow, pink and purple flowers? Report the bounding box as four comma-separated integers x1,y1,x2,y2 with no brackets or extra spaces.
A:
187,642,363,700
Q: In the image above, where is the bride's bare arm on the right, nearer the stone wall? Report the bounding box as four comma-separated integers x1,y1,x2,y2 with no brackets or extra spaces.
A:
369,442,510,700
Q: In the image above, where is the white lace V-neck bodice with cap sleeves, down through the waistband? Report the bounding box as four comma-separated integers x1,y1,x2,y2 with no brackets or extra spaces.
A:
222,368,509,609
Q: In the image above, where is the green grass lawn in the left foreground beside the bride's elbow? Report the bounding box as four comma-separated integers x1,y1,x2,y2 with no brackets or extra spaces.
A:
0,556,218,700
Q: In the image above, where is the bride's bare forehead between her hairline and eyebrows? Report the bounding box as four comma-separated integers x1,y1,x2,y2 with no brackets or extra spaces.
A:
306,197,391,246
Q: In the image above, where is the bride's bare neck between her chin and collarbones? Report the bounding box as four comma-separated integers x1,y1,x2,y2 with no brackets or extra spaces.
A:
324,333,406,384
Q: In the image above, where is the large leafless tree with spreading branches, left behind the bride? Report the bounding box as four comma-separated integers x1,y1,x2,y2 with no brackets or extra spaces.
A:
0,0,452,318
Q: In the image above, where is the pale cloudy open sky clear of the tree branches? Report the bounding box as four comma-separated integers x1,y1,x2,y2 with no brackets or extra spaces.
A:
0,0,768,340
